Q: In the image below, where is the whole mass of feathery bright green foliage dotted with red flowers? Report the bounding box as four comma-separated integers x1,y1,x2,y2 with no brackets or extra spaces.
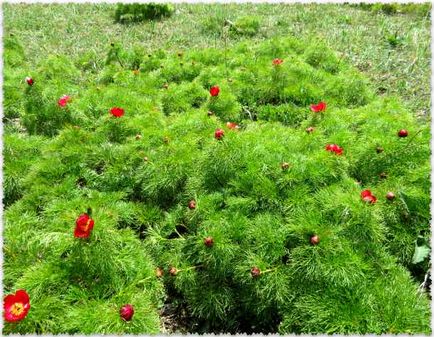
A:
4,25,430,334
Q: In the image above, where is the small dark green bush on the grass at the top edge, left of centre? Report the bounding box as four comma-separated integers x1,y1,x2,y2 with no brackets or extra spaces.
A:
114,3,173,23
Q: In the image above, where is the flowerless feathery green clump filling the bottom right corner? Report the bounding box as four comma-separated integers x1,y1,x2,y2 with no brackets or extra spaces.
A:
279,268,430,334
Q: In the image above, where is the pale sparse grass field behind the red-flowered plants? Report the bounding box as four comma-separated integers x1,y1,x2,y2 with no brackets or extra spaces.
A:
3,4,431,117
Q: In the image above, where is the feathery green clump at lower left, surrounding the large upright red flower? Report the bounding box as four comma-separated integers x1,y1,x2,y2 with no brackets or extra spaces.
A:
5,194,162,334
